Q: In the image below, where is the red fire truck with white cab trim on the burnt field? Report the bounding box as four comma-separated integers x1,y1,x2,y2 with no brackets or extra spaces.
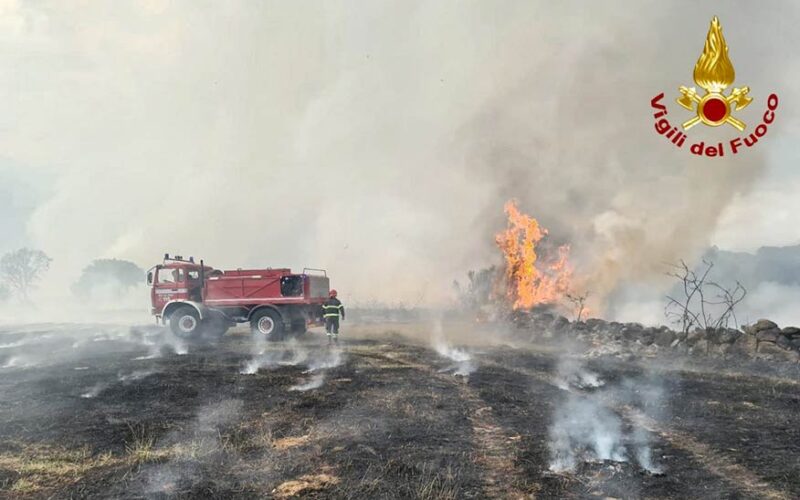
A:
147,254,330,340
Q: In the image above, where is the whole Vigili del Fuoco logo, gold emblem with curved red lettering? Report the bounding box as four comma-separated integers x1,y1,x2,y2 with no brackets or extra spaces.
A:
650,16,778,157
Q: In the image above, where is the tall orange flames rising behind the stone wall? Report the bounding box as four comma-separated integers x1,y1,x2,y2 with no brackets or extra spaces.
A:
495,200,572,309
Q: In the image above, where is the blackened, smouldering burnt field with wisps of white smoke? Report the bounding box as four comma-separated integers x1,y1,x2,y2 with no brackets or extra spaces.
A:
0,325,800,499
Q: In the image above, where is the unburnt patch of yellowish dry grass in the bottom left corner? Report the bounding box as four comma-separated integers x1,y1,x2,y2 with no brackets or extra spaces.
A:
0,444,118,495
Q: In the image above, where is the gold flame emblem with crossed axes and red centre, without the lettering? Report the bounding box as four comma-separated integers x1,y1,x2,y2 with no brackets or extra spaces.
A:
677,16,753,131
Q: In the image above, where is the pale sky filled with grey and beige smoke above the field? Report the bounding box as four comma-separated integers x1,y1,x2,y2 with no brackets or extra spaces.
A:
0,0,800,304
